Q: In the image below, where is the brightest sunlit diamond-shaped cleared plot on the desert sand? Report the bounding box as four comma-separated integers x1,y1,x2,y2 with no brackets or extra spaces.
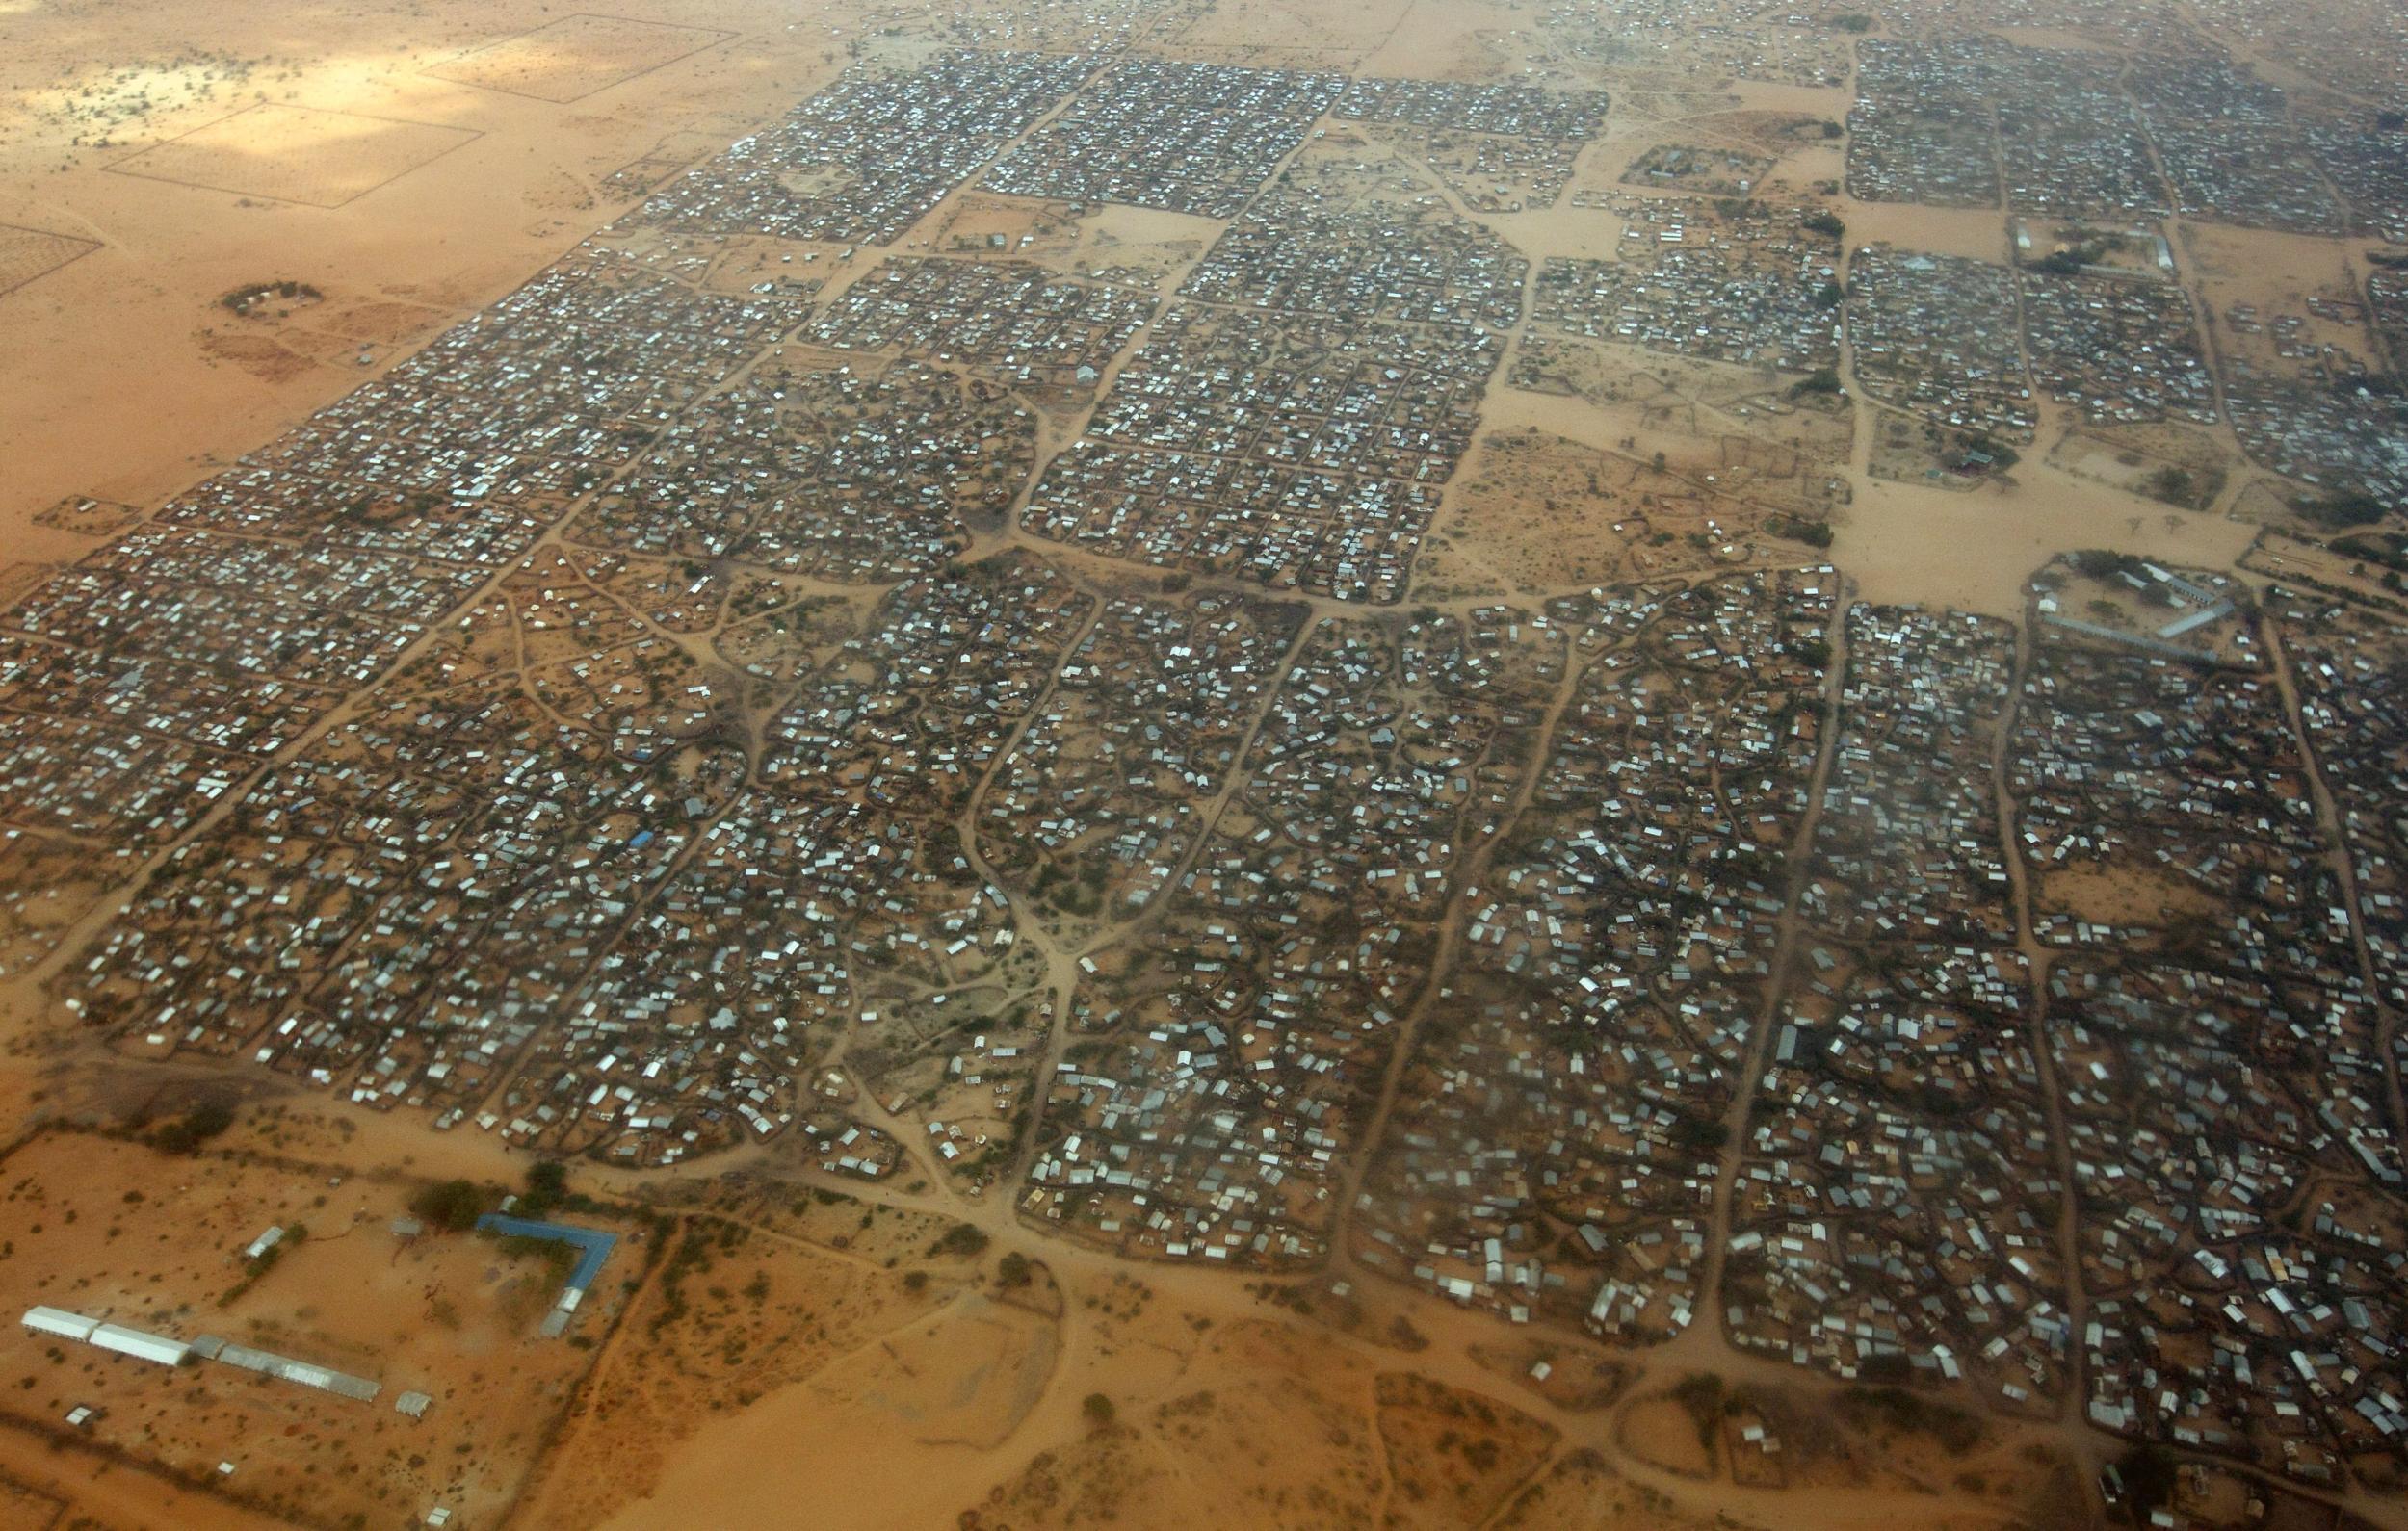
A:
109,106,477,207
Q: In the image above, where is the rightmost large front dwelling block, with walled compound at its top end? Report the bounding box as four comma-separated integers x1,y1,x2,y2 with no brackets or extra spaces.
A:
2008,557,2408,1486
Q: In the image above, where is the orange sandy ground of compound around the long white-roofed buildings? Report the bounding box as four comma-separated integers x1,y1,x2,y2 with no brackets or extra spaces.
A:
0,1131,612,1519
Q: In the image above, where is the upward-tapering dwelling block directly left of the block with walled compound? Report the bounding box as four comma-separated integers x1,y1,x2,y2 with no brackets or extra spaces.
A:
1722,605,2071,1414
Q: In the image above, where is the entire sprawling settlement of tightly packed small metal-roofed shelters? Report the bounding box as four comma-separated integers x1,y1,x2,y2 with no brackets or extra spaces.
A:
13,30,2408,1478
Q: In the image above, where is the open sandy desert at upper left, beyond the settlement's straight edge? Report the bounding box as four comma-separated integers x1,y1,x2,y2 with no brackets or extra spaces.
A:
0,0,843,558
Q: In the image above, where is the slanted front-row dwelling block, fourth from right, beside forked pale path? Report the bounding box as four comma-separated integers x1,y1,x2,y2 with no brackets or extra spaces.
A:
1026,607,1565,1266
